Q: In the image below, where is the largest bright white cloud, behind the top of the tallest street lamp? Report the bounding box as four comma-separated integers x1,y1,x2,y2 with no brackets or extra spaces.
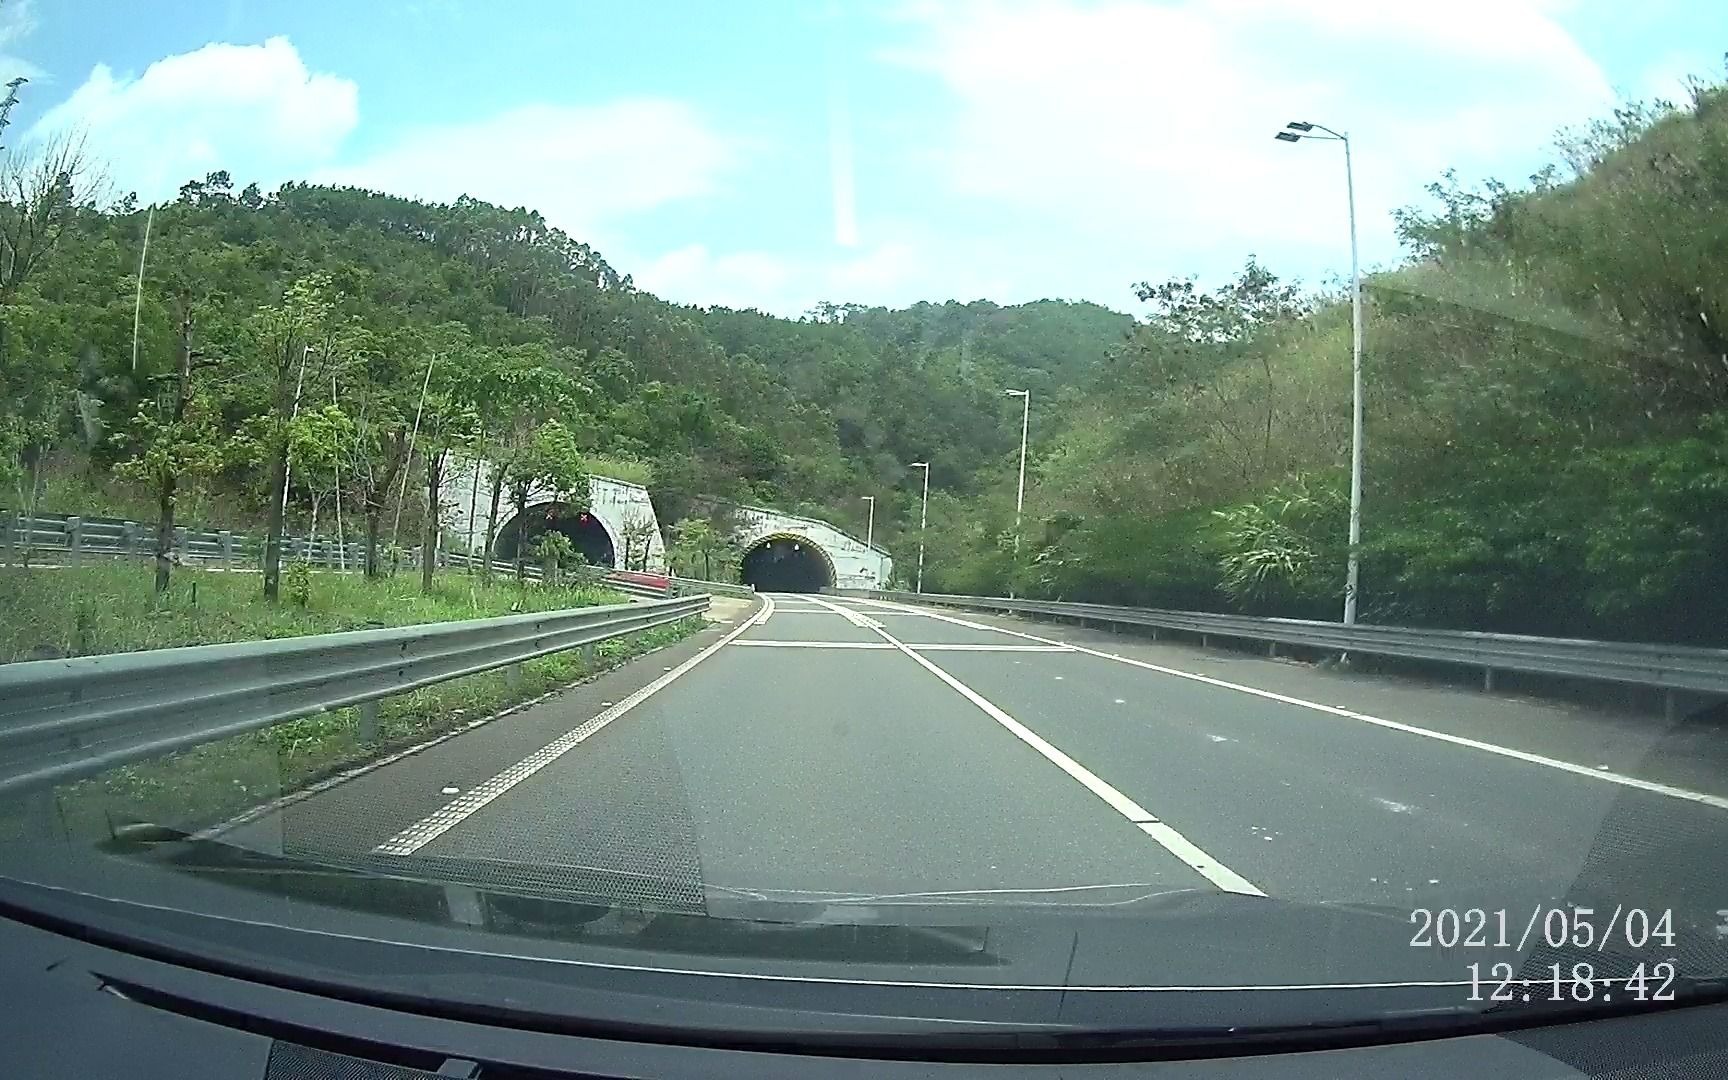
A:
885,0,1614,292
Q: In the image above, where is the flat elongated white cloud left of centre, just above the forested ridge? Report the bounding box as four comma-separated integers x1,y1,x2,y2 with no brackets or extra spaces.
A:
314,98,738,240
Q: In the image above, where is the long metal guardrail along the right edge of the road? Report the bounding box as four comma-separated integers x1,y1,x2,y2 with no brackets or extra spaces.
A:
842,589,1728,708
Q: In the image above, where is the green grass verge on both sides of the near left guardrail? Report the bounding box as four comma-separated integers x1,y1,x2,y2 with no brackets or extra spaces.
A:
0,565,705,838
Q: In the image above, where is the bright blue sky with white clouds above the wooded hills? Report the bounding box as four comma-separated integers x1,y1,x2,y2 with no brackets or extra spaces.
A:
0,0,1728,316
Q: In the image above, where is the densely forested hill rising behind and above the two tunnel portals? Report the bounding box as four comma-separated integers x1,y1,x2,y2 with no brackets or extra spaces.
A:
7,173,1132,552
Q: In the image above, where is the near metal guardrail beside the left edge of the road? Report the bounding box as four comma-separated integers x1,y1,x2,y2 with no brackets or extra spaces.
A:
0,584,708,795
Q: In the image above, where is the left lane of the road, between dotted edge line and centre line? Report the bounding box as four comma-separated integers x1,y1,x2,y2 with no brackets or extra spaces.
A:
385,598,1237,895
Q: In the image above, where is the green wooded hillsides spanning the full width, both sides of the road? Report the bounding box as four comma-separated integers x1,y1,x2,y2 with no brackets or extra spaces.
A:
0,77,1728,645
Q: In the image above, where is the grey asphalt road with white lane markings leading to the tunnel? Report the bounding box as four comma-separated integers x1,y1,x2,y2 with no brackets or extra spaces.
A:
228,596,1728,928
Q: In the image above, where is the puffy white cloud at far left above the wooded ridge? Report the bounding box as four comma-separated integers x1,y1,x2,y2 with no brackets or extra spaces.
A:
31,38,359,200
